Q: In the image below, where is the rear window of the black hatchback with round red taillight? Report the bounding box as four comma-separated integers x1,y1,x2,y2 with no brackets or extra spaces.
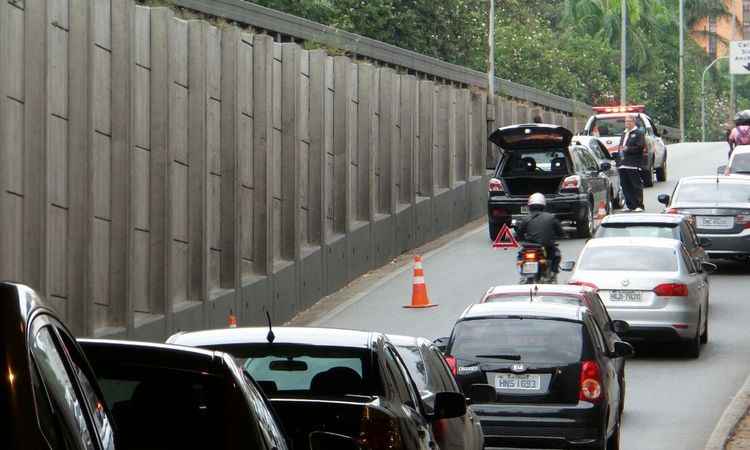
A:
450,317,583,364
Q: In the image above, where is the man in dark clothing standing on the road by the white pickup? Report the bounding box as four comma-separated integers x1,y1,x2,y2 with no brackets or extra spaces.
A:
617,116,646,211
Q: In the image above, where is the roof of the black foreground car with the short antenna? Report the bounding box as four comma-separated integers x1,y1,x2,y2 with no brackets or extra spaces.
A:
172,327,382,348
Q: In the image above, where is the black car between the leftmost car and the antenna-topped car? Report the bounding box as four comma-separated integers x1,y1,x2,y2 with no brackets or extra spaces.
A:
78,339,290,450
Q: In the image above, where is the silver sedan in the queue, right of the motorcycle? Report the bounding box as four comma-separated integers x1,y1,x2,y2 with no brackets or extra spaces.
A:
563,238,716,358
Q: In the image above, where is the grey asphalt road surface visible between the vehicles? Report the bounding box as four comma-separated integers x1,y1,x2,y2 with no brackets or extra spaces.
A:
318,144,750,450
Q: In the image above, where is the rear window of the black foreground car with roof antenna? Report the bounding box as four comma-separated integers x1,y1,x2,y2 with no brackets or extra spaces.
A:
206,344,381,397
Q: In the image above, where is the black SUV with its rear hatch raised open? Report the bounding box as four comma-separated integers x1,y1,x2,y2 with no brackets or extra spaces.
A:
488,124,612,239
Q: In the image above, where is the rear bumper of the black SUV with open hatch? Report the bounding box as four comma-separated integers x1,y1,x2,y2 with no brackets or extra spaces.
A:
487,194,589,225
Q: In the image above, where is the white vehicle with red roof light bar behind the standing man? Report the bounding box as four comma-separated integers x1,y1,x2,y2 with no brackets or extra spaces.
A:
582,105,667,187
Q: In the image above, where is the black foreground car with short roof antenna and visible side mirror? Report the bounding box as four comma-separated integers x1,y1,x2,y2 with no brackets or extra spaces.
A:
168,327,466,450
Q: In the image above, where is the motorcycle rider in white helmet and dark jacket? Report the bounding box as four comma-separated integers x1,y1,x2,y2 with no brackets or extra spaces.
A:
516,192,563,275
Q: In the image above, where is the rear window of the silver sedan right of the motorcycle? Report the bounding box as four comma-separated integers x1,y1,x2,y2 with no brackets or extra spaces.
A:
578,245,677,272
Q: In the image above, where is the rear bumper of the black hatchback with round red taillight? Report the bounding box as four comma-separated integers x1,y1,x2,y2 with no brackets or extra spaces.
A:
472,402,606,448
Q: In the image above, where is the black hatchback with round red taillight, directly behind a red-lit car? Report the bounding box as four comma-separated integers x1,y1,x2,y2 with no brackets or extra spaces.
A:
446,301,633,450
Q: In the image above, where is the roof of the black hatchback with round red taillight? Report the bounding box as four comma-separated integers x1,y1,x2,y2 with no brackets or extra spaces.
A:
459,302,588,321
